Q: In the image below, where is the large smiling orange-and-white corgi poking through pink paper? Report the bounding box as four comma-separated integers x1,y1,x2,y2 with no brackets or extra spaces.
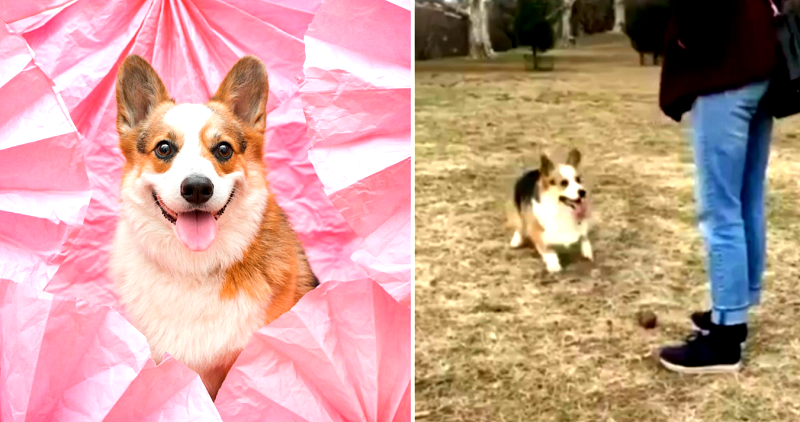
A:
110,55,318,398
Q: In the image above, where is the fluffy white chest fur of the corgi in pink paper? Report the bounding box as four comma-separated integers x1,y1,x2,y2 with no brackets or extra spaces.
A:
112,222,269,381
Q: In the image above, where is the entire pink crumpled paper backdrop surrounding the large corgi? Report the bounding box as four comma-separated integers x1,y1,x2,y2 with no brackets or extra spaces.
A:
0,0,412,421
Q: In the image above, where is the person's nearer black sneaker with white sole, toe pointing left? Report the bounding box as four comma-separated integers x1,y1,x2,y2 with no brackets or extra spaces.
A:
660,324,747,374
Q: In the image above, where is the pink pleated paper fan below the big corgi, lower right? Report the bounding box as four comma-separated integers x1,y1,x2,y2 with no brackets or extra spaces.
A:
216,279,411,422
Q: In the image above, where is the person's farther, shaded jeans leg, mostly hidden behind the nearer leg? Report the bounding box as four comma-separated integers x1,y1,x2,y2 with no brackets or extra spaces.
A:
742,102,772,306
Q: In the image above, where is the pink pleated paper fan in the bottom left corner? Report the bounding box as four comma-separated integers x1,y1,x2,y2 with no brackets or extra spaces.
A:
0,280,221,422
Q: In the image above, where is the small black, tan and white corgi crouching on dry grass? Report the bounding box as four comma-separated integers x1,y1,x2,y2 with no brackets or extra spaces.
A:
510,149,594,273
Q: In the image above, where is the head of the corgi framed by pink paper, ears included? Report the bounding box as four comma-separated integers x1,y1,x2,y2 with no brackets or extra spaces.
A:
116,56,268,252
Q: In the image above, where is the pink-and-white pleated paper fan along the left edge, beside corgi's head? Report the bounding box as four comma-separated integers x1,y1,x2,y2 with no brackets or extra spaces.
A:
0,22,91,289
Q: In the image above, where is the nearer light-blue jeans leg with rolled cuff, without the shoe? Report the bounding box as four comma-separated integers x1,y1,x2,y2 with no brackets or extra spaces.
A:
692,83,766,325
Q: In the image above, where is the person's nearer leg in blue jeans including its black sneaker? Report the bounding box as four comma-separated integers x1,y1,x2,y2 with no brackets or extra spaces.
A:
661,82,767,372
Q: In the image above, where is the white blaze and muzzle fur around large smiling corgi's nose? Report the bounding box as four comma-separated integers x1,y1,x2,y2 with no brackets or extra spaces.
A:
142,104,244,212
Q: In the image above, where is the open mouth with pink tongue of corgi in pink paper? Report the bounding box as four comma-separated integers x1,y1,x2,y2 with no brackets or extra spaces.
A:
153,189,236,252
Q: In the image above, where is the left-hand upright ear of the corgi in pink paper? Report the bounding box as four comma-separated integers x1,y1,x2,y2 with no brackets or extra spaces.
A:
117,55,172,136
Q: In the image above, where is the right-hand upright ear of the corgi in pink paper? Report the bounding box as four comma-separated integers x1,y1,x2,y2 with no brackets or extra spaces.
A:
211,56,269,133
